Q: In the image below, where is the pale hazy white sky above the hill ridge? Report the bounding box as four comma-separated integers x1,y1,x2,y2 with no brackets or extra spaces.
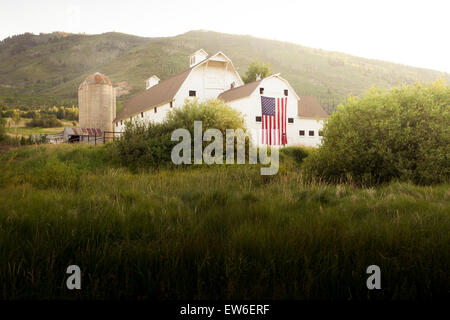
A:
0,0,450,72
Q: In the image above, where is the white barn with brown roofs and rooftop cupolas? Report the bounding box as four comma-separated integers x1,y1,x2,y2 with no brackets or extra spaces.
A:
114,49,328,146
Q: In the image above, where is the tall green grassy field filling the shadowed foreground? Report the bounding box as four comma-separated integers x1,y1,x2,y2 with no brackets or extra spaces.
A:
0,145,450,300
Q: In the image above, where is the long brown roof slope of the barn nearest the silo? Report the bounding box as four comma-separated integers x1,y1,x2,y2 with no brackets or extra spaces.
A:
114,67,193,122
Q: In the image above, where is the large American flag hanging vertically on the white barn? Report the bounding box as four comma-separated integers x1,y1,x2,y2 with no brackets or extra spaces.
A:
261,96,287,145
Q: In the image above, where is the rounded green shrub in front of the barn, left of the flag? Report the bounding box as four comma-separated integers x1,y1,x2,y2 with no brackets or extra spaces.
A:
115,99,244,168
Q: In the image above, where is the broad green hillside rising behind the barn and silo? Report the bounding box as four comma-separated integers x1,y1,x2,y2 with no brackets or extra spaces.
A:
0,31,450,112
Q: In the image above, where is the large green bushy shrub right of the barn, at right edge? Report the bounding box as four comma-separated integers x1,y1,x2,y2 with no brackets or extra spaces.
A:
304,81,450,185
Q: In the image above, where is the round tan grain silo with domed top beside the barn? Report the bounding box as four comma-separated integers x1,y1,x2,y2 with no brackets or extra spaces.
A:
78,72,116,131
